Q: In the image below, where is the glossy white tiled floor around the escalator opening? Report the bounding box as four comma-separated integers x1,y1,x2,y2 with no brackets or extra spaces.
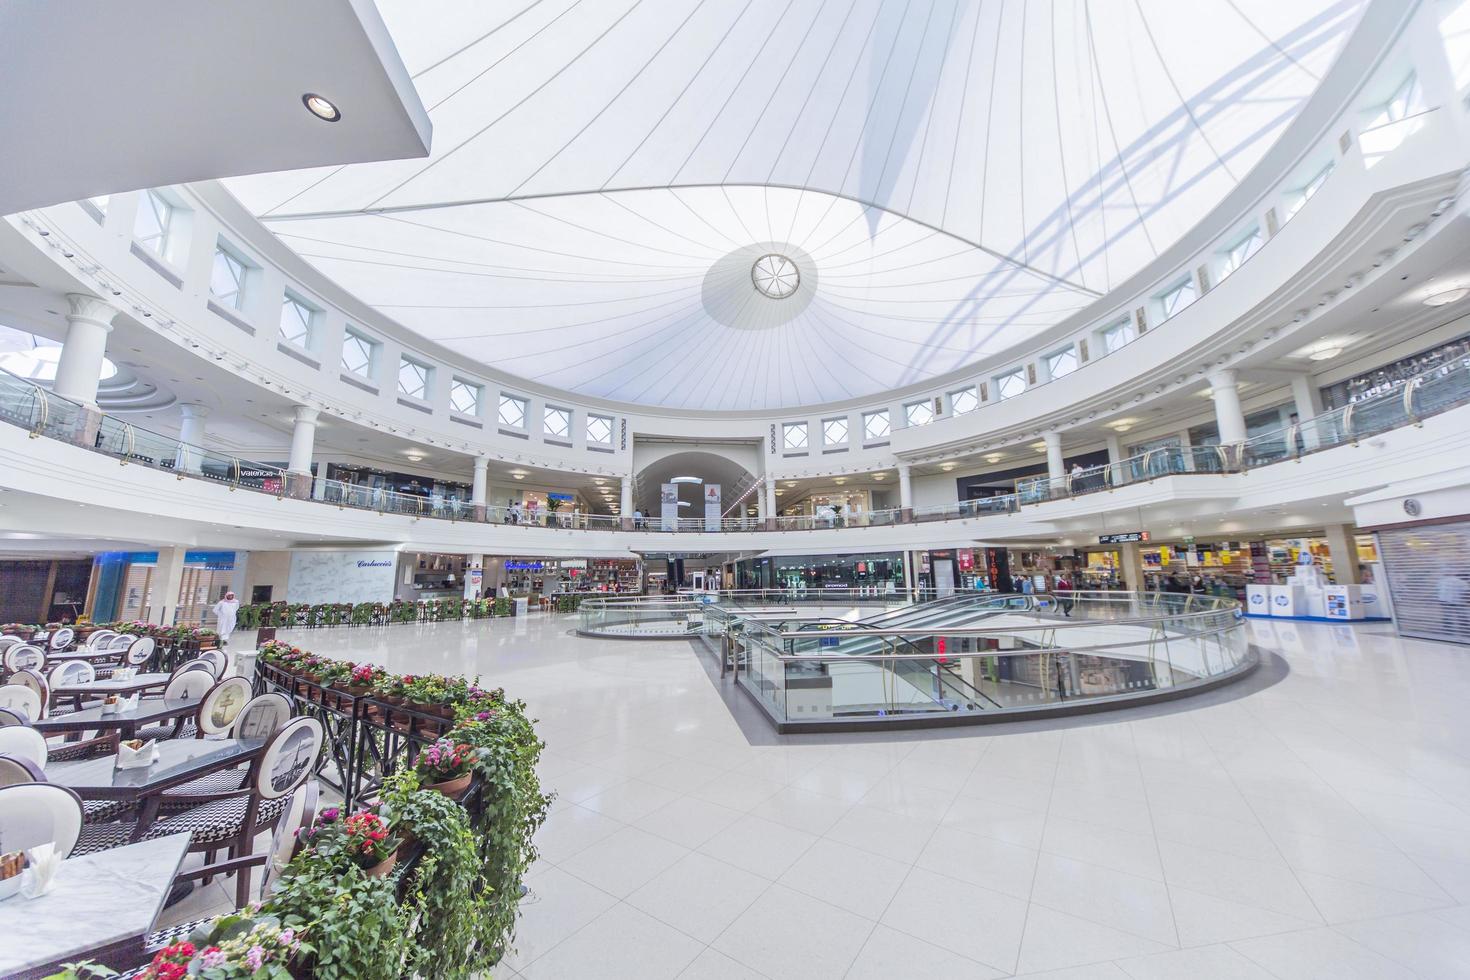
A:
273,617,1470,980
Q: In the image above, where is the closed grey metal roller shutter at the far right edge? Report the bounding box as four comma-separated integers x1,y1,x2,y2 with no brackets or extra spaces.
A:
1379,520,1470,644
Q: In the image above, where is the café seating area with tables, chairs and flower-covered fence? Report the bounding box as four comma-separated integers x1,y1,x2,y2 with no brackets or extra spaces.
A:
0,629,548,977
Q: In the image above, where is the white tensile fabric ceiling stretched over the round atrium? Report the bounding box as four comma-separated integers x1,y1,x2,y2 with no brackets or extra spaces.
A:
226,0,1363,410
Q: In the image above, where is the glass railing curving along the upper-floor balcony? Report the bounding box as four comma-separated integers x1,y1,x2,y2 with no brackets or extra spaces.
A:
0,357,1470,533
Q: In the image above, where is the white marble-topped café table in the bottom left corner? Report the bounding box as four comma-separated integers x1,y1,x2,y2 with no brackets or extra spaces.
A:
0,833,190,980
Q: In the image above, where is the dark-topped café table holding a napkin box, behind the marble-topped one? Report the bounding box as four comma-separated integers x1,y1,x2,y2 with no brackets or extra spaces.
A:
46,739,266,840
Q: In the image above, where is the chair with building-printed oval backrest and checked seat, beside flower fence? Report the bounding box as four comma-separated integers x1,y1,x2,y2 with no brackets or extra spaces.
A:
75,716,325,907
